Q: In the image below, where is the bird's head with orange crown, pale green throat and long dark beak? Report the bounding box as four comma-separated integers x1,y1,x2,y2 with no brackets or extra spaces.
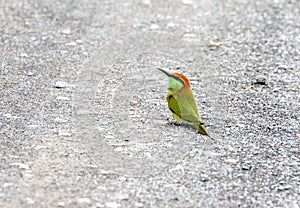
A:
157,68,190,92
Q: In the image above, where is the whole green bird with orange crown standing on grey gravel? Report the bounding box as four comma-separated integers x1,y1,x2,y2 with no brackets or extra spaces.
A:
157,68,208,135
